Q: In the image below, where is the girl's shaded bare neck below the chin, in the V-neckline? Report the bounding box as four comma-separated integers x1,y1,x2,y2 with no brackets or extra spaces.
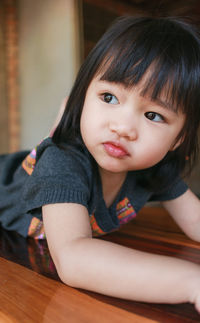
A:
99,167,127,207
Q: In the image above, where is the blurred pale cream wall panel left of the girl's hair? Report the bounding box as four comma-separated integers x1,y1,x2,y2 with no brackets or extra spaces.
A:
19,0,81,149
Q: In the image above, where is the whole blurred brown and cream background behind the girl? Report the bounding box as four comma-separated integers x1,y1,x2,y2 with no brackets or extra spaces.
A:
0,0,200,195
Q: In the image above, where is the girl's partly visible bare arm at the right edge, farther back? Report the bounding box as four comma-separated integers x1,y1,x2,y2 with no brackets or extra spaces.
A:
163,189,200,242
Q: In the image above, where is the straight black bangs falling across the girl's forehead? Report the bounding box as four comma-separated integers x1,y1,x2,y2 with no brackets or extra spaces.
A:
97,19,200,113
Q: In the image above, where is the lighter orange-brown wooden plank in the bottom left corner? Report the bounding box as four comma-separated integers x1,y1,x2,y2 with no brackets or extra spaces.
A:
0,258,155,323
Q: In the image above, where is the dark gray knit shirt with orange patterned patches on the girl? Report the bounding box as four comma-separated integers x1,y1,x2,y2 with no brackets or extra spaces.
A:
0,138,187,238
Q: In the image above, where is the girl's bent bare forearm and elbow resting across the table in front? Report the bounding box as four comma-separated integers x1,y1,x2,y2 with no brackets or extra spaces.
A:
43,203,200,312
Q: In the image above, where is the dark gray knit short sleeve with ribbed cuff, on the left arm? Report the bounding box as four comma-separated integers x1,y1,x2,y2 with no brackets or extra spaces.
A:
22,139,91,212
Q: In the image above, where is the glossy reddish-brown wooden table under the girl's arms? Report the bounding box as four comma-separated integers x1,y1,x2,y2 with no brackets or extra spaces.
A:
0,207,200,323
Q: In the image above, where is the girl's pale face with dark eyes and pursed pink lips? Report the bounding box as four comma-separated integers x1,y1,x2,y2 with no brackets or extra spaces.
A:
80,76,185,177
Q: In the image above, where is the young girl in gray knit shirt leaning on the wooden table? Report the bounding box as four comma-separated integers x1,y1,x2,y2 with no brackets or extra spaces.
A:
0,17,200,312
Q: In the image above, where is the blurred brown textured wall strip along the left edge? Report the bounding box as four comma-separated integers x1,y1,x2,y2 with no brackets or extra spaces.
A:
0,0,20,153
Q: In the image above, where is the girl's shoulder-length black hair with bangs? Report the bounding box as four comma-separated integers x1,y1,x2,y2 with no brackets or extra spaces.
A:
52,17,200,190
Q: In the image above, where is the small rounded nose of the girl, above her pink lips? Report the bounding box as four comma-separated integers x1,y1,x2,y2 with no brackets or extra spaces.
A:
110,120,138,140
